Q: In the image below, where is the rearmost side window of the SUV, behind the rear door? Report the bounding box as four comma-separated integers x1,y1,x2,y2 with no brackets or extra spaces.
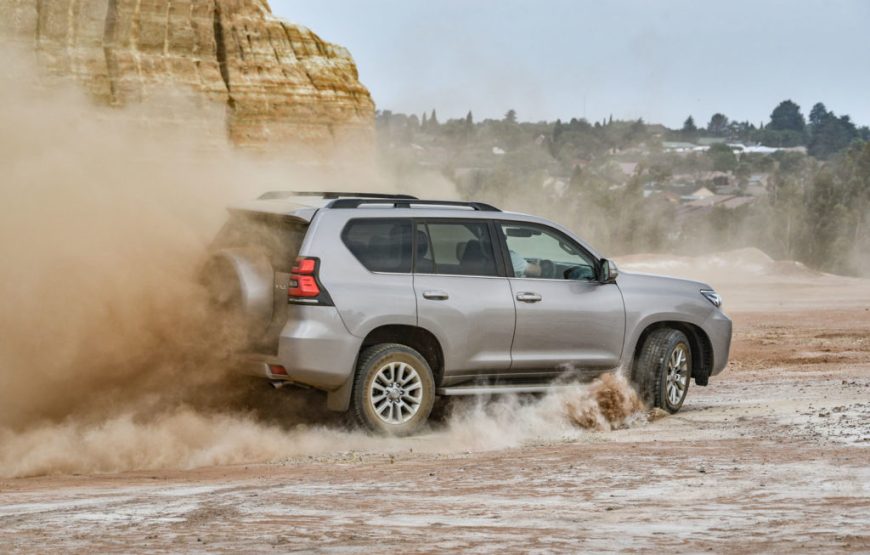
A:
341,218,412,273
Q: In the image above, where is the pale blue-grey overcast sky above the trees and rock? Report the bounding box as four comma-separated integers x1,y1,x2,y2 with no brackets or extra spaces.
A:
270,0,870,127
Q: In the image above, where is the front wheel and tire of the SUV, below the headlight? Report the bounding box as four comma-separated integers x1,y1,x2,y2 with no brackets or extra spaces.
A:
632,328,692,414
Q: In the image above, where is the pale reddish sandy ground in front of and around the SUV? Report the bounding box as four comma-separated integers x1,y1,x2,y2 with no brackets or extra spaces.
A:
0,253,870,552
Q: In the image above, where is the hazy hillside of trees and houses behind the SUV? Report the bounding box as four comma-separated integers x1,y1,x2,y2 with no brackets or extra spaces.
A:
377,100,870,275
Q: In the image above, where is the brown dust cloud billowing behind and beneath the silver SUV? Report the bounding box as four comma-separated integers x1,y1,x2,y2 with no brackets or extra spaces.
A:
0,47,648,477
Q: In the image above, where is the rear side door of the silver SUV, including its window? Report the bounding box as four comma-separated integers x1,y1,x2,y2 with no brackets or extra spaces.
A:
414,219,515,378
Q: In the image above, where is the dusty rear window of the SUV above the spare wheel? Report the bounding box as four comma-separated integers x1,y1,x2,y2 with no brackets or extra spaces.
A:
213,212,308,273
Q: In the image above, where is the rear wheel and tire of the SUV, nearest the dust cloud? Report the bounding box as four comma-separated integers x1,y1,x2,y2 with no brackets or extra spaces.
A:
350,343,435,436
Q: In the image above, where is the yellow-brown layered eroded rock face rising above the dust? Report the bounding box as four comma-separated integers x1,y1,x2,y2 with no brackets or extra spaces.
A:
0,0,374,147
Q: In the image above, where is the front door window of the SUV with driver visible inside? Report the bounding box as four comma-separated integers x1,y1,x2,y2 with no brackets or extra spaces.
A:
500,223,595,281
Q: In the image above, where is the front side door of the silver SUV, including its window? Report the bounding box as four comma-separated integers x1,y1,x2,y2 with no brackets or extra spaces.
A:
497,222,625,374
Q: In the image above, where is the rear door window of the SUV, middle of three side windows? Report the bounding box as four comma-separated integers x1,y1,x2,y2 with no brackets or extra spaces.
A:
415,221,498,276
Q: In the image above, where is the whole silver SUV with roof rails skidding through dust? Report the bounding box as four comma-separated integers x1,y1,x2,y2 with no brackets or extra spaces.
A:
206,192,731,434
